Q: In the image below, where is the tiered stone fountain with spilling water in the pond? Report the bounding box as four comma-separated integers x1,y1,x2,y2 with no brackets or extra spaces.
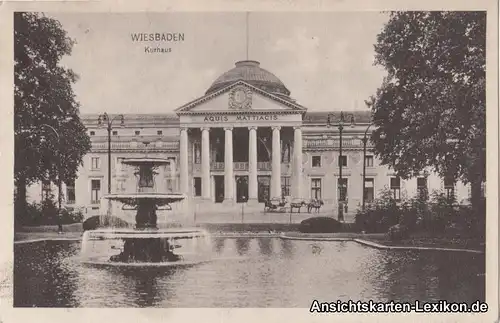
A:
82,152,209,267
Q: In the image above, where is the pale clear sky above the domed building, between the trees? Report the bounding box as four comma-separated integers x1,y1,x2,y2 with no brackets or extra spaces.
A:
46,12,388,114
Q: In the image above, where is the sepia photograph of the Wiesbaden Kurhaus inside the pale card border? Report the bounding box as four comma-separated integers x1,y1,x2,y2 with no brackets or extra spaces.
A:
3,5,498,314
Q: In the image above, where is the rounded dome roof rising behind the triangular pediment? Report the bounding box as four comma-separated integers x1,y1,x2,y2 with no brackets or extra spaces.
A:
205,61,290,97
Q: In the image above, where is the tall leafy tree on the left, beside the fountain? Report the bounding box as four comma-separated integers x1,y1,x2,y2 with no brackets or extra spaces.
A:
14,12,91,220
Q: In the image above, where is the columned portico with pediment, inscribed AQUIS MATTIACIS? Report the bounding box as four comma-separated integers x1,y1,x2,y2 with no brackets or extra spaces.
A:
177,81,306,204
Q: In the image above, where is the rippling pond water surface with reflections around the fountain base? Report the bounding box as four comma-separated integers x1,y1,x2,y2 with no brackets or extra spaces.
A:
14,238,485,307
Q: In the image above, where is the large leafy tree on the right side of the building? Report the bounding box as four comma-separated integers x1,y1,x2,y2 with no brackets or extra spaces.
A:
367,12,486,210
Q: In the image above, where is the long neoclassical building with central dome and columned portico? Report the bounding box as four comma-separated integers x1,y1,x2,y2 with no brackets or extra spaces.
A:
29,61,469,216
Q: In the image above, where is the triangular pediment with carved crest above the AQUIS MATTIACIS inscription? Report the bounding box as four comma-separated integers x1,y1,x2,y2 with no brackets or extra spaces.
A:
176,81,307,115
